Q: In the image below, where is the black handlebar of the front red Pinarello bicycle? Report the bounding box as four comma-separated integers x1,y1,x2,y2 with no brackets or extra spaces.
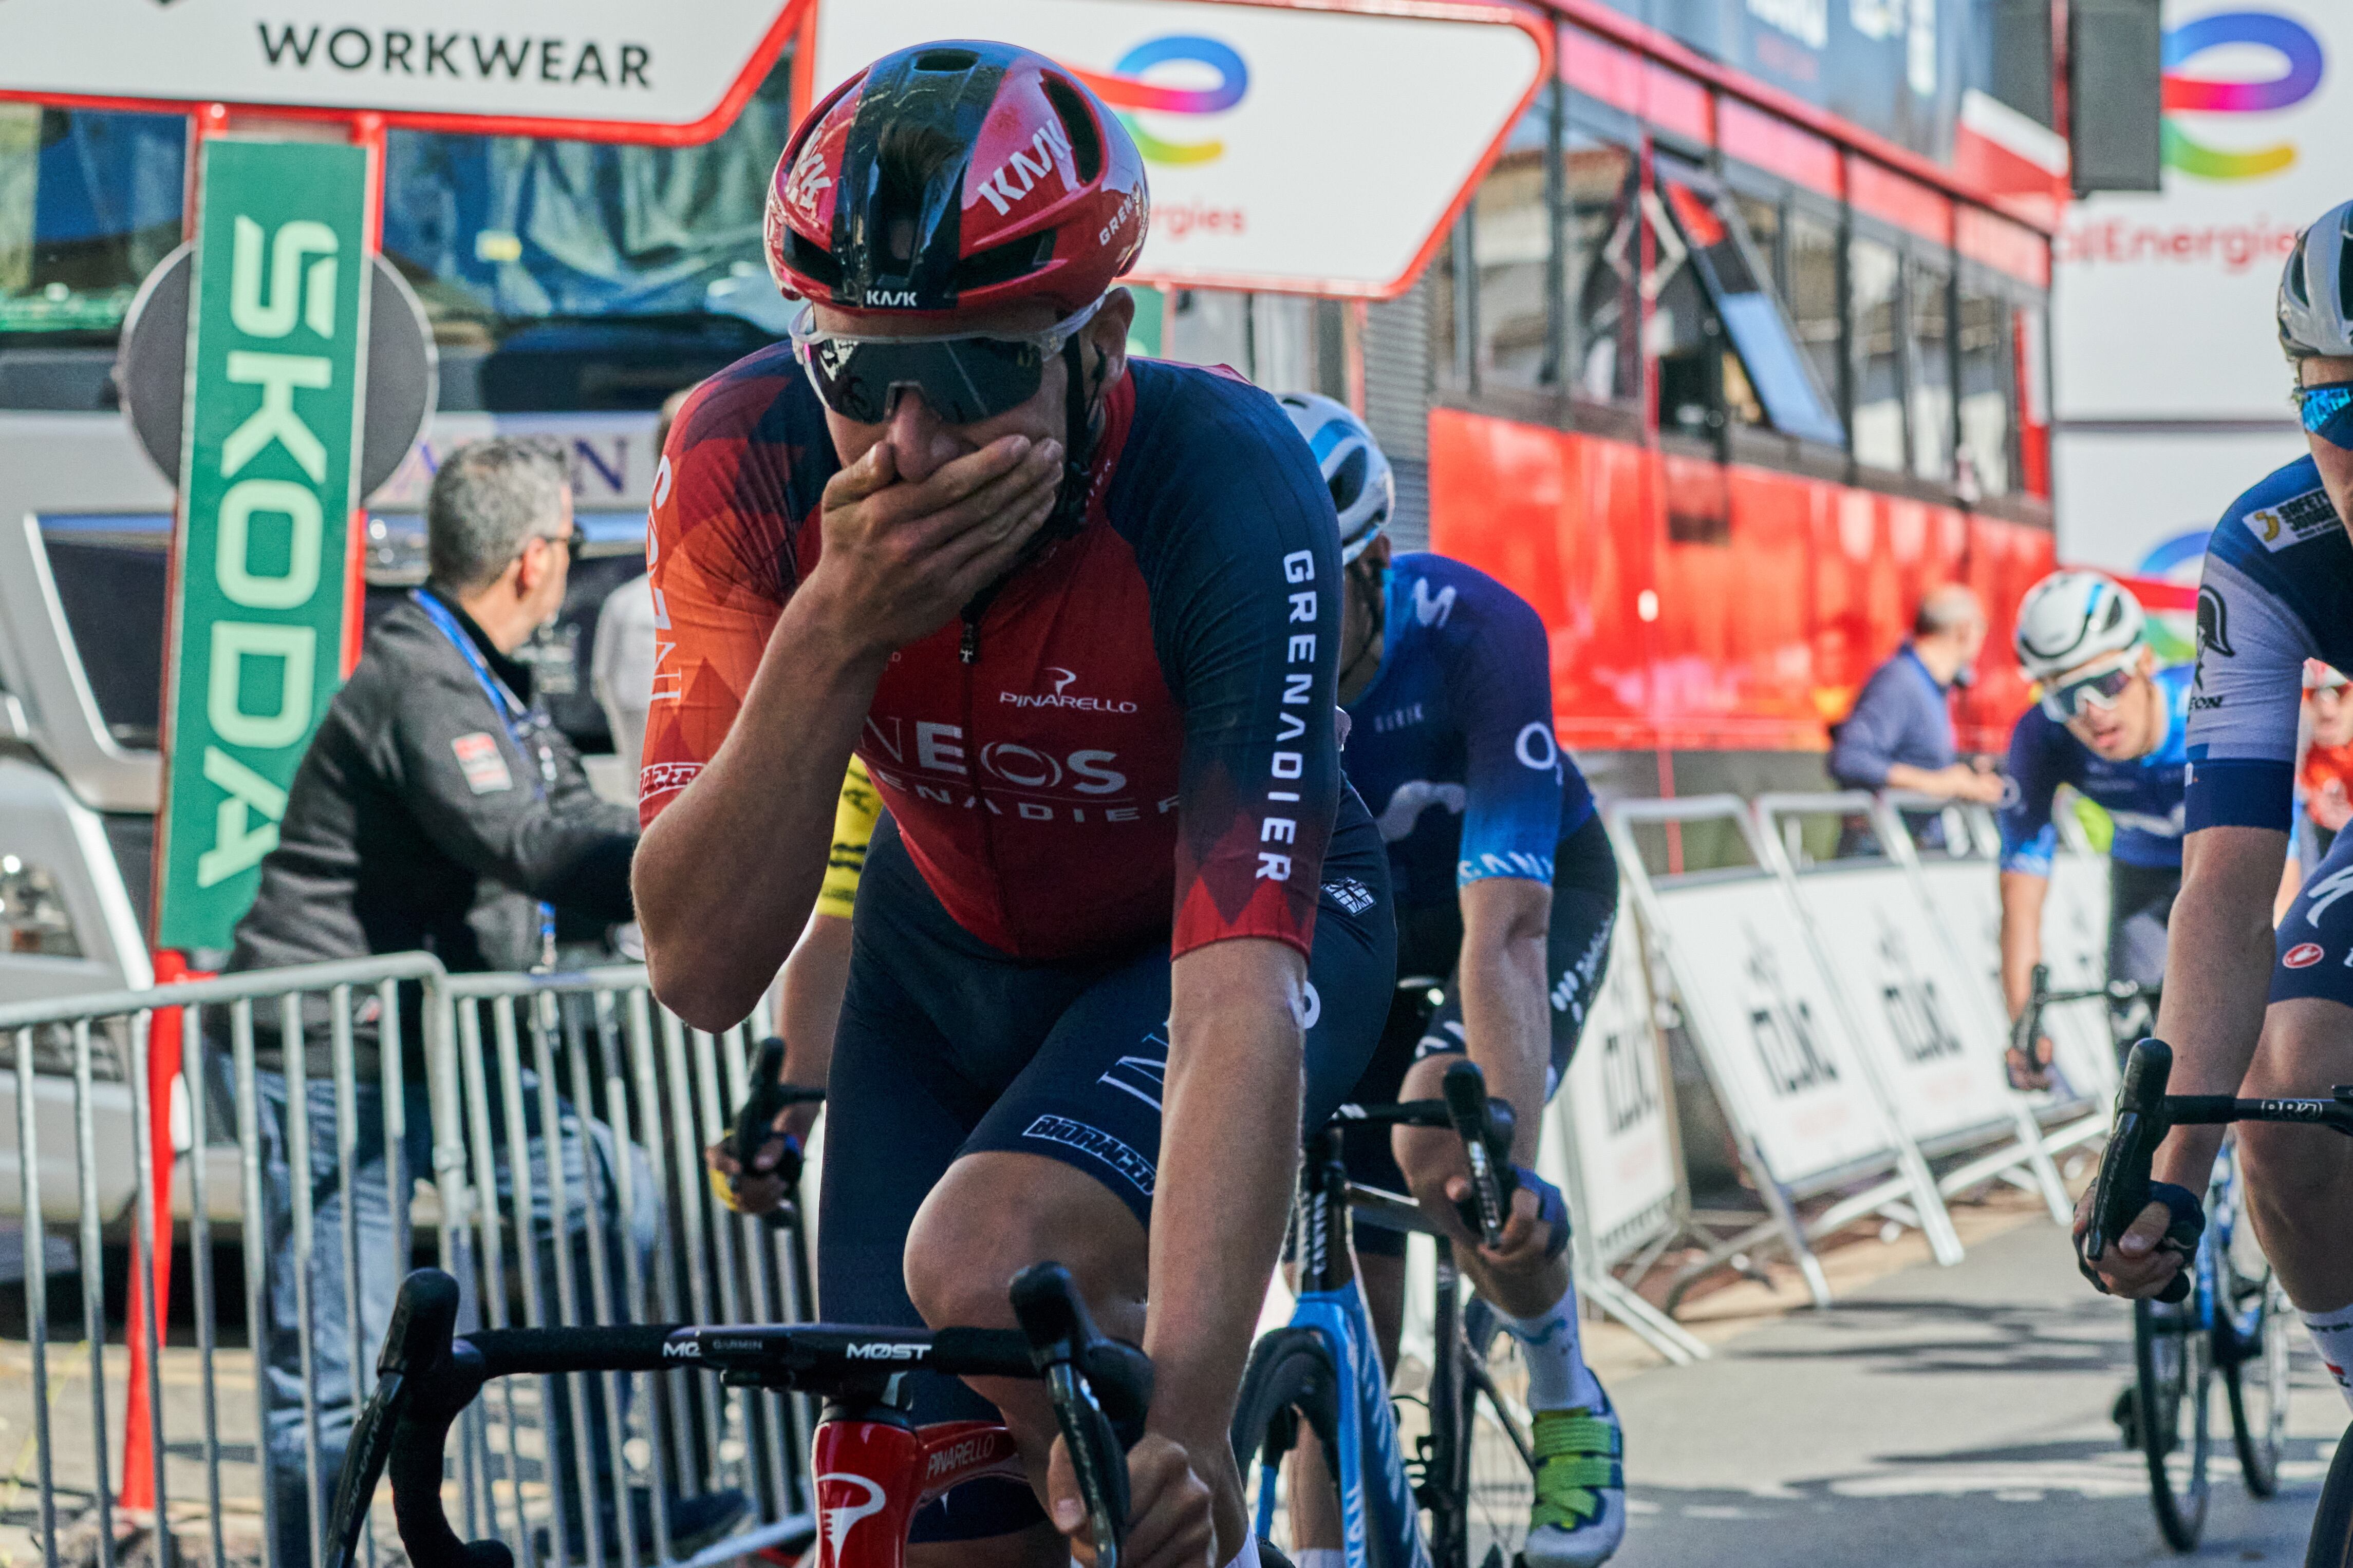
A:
327,1262,1153,1568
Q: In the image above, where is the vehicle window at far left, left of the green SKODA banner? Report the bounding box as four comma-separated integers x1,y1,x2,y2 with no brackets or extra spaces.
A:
0,103,188,341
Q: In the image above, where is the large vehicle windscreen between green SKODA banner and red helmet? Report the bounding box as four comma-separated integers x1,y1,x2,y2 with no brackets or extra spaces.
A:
384,56,793,341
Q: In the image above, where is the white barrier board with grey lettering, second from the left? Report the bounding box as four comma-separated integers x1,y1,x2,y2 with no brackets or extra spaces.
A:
1656,877,1894,1187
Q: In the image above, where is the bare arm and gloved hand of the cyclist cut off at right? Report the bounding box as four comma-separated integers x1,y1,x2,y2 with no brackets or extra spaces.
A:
2078,827,2287,1295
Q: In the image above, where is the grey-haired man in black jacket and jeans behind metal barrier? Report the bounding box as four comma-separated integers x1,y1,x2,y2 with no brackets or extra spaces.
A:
228,440,743,1568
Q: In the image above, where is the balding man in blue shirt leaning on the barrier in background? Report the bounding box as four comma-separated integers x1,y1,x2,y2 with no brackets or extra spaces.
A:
1831,583,2003,806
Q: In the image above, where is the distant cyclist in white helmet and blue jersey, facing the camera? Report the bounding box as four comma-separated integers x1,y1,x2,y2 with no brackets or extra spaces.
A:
1997,571,2191,1088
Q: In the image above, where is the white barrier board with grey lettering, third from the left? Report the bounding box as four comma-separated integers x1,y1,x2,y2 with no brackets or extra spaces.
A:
1798,865,2016,1152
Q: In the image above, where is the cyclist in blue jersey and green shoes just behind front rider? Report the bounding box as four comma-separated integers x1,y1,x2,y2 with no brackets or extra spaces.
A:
1282,395,1626,1568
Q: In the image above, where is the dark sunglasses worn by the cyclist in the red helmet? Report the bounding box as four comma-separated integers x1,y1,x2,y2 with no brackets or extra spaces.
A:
791,301,1104,425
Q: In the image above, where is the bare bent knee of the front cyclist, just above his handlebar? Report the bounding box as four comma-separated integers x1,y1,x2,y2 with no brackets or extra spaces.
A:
906,1149,1146,1340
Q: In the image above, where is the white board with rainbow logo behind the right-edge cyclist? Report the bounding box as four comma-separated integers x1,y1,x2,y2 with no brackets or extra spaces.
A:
2052,0,2353,576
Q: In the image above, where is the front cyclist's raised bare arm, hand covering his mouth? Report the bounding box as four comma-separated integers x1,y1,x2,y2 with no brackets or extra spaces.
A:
633,435,1061,1030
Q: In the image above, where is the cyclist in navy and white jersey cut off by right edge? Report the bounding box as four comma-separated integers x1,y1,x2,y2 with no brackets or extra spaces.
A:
2076,202,2353,1404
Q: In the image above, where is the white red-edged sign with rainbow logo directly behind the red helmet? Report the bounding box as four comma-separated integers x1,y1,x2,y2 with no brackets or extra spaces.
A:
816,0,1546,298
